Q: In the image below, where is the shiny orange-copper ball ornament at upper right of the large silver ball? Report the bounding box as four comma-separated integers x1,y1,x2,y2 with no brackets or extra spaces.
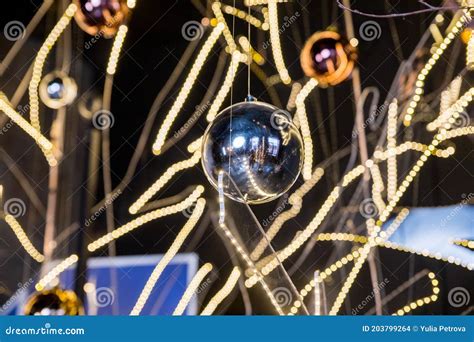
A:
300,31,357,86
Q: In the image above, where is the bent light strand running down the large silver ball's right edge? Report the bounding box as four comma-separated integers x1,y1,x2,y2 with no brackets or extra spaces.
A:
296,78,318,180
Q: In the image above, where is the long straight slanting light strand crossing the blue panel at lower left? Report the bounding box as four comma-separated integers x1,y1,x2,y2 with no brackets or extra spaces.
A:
130,198,206,316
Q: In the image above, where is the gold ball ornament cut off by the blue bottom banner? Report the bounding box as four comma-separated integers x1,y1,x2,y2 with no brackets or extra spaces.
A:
25,287,84,316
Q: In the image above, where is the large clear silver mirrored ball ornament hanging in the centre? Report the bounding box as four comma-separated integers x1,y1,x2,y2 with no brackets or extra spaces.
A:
202,99,303,204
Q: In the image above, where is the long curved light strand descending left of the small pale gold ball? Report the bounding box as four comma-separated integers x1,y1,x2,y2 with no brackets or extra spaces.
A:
28,4,77,166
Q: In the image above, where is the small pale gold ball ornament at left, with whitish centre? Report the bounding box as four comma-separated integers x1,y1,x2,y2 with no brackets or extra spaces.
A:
39,71,77,109
